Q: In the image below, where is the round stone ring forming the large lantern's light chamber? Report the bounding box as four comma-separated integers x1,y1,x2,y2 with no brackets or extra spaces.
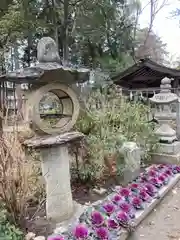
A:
26,83,80,134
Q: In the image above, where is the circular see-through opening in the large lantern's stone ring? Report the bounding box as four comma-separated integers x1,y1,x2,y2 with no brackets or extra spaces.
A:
39,89,73,128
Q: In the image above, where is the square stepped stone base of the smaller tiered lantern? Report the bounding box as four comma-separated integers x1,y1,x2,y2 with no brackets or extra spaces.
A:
152,141,180,165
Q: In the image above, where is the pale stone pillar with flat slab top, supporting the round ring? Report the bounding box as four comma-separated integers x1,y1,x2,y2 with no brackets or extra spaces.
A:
24,132,84,222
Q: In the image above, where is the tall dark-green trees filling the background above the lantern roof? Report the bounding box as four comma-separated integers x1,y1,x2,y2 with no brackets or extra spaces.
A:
0,0,167,73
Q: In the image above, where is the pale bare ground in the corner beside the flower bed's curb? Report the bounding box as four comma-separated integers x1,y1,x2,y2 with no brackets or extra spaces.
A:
129,182,180,240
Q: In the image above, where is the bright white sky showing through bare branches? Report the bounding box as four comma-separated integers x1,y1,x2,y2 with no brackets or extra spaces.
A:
139,0,180,64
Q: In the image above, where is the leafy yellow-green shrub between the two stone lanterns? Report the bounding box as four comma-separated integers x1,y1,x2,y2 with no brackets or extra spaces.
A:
76,85,158,179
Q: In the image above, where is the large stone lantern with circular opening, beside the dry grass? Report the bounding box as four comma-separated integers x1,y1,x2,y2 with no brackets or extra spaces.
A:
0,37,89,222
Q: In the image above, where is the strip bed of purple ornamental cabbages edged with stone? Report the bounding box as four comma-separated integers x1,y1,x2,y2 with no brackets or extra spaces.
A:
48,164,180,240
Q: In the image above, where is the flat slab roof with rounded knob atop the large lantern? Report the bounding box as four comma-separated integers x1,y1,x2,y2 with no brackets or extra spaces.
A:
0,37,90,85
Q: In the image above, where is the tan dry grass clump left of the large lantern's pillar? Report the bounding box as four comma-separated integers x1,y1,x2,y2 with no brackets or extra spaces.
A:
0,131,41,224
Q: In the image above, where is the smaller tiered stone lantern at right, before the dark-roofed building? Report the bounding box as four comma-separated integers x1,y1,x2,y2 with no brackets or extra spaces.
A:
150,78,180,164
